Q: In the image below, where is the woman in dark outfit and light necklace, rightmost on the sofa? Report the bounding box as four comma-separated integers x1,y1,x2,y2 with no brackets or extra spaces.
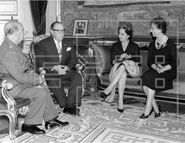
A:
140,17,177,119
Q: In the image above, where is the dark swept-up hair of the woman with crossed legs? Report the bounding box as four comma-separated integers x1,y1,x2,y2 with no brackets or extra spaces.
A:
118,21,133,39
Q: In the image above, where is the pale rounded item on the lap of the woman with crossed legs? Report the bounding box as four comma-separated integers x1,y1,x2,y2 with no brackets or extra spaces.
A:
123,60,140,77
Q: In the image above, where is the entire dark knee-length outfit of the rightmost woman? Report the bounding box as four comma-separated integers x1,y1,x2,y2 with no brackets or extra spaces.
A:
141,39,177,92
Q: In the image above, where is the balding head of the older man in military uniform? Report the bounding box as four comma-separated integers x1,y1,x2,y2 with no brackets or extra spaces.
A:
4,20,24,44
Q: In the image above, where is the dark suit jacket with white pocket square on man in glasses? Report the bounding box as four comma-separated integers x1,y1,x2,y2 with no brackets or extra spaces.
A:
35,36,77,74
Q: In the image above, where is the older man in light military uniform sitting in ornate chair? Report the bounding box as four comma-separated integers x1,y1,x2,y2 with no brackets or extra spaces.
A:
0,21,69,134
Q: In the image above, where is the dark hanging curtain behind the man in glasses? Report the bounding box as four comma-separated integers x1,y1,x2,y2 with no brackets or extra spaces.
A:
30,0,48,36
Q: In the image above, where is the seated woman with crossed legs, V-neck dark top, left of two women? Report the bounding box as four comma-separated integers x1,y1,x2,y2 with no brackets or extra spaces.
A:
100,22,139,112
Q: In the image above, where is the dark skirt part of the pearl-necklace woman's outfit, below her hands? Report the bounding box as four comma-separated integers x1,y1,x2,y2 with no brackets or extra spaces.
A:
141,69,175,92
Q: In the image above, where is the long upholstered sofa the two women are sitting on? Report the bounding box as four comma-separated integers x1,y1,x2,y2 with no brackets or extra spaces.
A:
89,39,185,110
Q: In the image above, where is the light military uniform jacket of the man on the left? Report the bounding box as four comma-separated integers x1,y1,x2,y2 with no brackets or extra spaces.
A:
0,38,39,96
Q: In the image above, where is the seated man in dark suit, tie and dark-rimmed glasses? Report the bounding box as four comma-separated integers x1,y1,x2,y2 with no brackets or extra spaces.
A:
35,22,82,115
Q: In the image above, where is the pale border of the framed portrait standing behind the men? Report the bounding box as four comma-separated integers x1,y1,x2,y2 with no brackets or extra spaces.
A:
73,19,88,36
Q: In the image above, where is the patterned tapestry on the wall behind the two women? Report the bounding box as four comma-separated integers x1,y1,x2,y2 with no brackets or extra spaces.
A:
61,1,185,36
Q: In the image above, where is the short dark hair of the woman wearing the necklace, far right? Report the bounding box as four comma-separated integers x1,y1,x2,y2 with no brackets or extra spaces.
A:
150,16,167,34
